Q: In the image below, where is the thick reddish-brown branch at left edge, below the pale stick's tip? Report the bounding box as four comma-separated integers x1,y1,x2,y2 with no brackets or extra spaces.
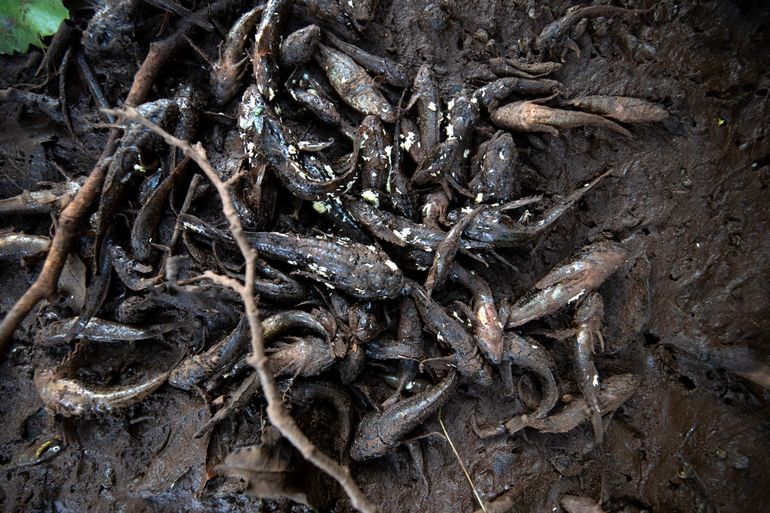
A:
0,134,118,359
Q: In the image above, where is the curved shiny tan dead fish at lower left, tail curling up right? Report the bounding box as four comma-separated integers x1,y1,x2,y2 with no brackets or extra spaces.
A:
35,364,169,417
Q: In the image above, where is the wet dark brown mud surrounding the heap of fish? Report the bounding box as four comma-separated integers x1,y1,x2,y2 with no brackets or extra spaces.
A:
0,0,770,513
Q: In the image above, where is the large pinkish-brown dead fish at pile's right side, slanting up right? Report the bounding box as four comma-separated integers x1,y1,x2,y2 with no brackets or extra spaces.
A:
505,241,628,329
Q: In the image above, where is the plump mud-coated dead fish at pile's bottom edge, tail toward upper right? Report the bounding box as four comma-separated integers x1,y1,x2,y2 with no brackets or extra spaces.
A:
350,371,458,461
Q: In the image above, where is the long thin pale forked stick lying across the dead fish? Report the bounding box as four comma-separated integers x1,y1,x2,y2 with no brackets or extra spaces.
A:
105,107,378,513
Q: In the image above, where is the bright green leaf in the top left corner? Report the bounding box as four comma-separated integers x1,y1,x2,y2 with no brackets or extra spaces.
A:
0,0,69,54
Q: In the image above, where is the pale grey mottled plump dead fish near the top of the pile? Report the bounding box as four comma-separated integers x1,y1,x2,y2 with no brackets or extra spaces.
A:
316,45,396,123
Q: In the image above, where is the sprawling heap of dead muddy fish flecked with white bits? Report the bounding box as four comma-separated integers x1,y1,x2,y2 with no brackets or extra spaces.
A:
0,0,667,504
